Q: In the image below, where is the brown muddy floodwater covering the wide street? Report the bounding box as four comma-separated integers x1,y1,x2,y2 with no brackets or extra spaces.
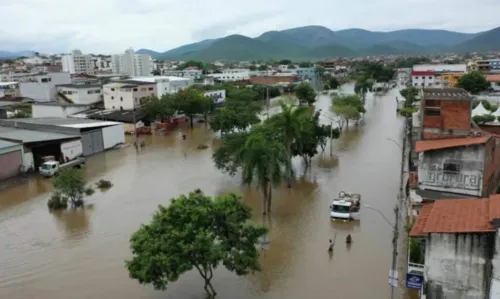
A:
0,86,402,299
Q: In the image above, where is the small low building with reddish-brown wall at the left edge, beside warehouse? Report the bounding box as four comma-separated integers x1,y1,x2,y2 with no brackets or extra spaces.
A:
0,140,23,180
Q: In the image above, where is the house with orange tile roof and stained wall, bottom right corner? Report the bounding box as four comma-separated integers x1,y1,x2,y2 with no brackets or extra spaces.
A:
409,195,500,299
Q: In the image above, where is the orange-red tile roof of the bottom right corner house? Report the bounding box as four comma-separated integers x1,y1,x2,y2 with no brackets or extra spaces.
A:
410,195,500,237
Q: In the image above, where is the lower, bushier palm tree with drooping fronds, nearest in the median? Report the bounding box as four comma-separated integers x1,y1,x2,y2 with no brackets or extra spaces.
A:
236,130,287,215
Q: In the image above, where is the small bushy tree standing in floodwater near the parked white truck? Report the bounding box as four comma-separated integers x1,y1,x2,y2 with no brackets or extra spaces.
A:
48,168,94,209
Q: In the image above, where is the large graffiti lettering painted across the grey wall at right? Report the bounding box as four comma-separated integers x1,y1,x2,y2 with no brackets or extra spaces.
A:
421,170,483,190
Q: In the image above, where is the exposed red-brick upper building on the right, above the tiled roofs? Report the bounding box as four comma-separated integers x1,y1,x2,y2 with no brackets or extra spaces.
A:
420,88,472,140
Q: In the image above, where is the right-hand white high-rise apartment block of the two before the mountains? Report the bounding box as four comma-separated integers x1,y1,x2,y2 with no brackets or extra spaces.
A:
111,48,152,77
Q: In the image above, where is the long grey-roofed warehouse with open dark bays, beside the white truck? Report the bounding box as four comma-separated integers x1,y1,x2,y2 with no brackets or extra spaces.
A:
0,117,125,167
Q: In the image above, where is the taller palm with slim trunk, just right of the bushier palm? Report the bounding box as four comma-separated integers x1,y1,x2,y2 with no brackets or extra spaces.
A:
269,101,308,187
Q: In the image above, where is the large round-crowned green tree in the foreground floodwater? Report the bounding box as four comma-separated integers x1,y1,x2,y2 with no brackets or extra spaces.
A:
125,190,267,298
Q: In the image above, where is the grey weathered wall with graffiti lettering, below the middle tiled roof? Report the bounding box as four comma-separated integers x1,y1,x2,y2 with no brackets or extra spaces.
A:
418,145,485,196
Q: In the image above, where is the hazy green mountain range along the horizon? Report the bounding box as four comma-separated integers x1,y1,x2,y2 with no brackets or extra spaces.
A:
137,26,500,61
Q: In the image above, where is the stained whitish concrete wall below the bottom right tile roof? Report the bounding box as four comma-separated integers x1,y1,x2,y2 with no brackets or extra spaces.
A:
424,233,498,299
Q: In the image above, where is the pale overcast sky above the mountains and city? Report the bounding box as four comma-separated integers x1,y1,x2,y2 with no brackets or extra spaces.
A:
0,0,500,54
